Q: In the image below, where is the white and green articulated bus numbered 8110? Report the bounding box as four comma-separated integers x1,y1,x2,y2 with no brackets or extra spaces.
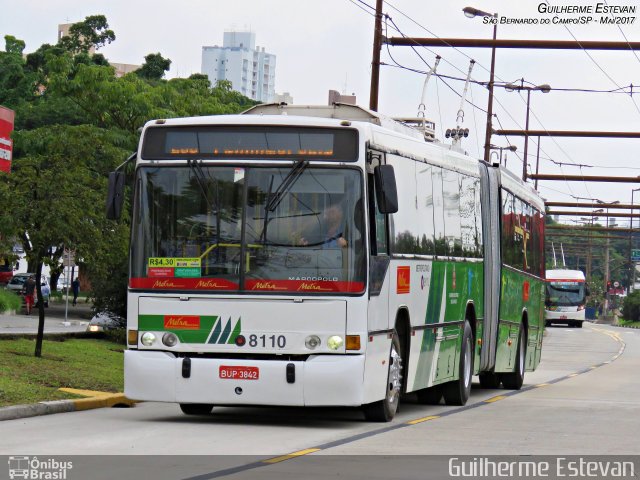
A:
107,104,544,421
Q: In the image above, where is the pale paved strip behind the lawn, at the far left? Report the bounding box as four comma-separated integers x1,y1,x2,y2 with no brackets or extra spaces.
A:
0,299,93,336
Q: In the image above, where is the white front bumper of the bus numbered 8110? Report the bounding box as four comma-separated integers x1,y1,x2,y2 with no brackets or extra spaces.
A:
124,350,365,406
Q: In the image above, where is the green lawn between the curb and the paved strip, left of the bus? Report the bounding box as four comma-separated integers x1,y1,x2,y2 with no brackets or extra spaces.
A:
0,338,124,407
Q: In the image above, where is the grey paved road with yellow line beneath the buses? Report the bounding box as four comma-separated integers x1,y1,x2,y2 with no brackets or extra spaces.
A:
0,324,640,478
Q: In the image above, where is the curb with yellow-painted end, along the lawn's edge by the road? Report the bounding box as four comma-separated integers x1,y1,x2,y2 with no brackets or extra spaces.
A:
0,393,137,422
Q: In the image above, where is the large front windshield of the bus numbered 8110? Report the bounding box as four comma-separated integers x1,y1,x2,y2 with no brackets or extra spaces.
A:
130,161,365,294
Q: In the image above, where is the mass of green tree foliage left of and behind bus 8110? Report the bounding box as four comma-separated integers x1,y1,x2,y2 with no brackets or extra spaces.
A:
0,15,256,344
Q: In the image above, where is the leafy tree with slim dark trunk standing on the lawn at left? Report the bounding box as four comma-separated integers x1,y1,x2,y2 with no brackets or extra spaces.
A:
0,125,126,356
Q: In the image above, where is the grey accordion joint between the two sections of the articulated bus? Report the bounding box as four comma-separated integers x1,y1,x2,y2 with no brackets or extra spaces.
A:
480,162,501,372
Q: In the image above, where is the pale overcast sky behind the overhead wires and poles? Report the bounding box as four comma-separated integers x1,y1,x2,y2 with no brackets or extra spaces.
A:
0,0,640,226
